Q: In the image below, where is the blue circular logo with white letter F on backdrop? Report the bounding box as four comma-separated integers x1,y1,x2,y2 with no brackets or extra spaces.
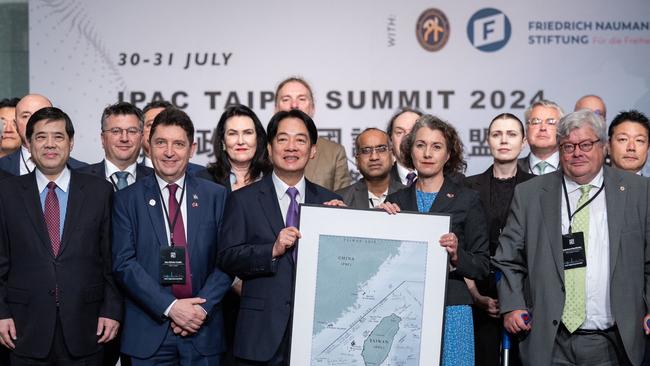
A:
467,8,512,52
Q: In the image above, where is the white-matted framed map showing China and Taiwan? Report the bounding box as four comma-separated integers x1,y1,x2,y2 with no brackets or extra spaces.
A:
291,205,450,366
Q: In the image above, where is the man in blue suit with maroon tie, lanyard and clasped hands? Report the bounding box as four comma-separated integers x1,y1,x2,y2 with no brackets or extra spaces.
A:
113,107,232,366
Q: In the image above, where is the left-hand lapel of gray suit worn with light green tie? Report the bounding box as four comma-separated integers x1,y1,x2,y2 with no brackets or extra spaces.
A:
536,170,564,281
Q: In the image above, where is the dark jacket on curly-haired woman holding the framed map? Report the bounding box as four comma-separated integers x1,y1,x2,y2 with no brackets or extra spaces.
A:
386,177,490,305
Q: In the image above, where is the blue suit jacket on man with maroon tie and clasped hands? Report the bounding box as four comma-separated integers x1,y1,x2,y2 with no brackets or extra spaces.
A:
113,174,232,358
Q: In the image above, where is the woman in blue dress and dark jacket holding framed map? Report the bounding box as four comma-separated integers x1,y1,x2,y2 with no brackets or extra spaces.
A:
381,115,489,365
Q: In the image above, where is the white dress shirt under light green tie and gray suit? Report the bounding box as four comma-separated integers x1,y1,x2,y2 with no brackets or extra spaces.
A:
561,168,614,330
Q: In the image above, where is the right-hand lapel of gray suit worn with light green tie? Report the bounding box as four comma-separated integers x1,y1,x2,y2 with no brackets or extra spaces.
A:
603,167,629,276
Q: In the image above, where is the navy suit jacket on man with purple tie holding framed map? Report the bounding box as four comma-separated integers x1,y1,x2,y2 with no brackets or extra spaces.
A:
219,174,340,362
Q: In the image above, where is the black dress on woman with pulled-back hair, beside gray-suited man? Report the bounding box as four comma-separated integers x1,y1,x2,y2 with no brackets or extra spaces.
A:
465,166,535,365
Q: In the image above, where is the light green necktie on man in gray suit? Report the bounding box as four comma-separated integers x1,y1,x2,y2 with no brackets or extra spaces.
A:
562,184,591,333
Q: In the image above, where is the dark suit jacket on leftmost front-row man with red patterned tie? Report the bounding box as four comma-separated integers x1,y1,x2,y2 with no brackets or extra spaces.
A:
0,171,122,358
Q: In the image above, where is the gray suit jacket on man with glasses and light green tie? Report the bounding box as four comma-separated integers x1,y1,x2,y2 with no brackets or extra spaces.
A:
493,166,650,365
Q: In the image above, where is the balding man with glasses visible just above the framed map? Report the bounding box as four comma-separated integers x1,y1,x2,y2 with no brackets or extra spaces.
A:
336,128,405,208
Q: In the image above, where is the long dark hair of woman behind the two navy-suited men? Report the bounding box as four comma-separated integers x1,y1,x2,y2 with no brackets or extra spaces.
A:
208,104,273,183
